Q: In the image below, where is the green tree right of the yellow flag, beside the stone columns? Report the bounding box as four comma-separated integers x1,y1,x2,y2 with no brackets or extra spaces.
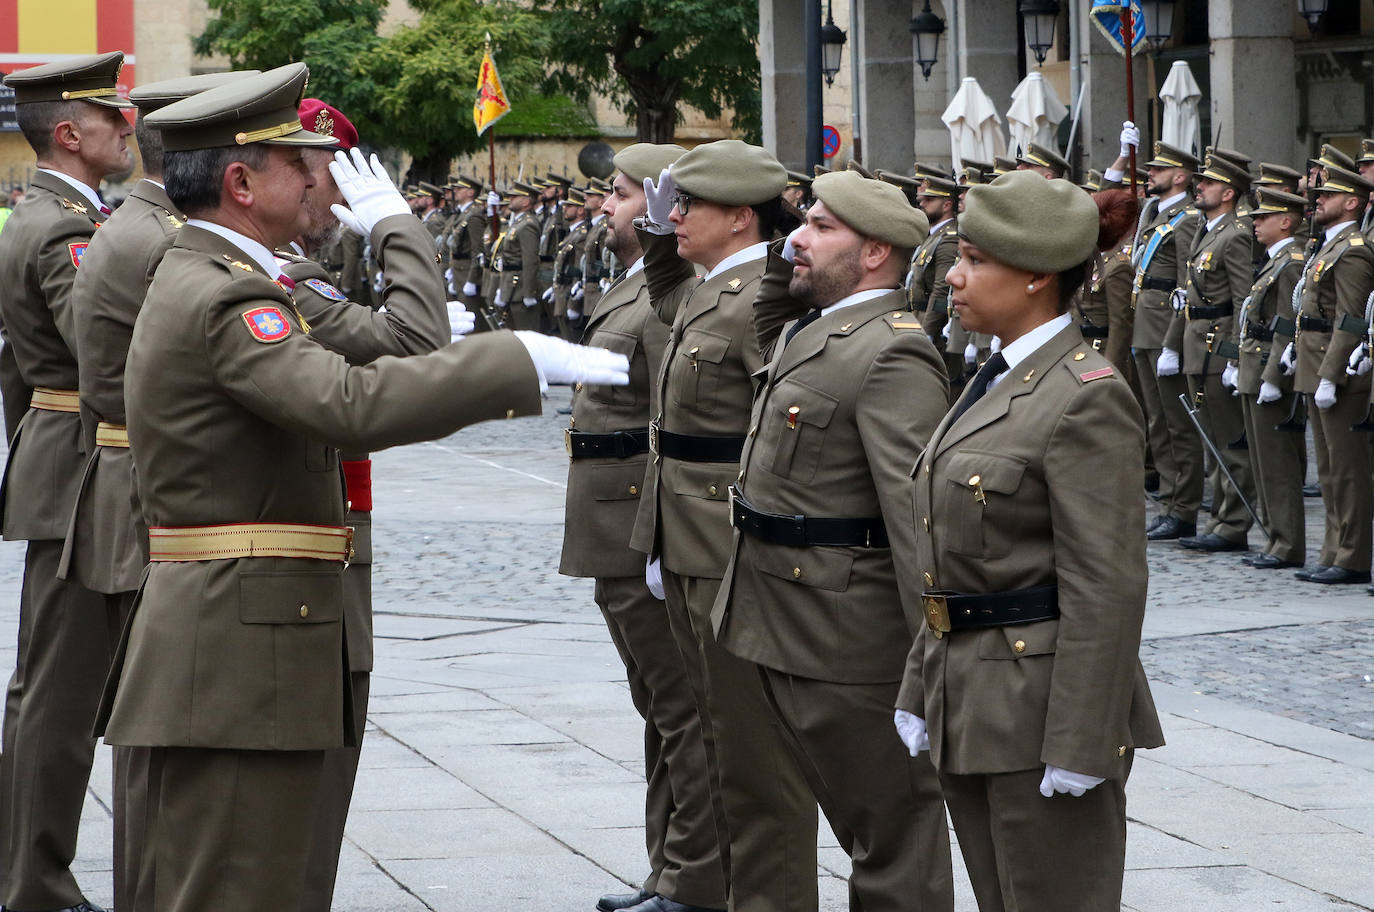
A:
536,0,763,143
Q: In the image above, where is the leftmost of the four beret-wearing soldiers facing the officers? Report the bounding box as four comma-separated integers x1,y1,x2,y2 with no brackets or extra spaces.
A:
559,143,725,912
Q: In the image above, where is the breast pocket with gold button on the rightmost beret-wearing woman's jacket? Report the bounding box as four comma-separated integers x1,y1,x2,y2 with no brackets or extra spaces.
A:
936,451,1026,555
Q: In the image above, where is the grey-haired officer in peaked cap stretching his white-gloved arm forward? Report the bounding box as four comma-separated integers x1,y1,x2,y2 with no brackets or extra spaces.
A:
96,65,627,912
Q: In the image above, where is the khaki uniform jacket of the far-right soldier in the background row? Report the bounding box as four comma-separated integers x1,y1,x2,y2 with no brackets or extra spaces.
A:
1291,223,1374,393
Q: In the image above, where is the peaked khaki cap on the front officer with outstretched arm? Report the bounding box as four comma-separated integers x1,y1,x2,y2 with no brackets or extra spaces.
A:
144,63,337,152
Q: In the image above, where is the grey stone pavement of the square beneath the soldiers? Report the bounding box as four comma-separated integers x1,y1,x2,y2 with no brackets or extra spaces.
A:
0,389,1374,912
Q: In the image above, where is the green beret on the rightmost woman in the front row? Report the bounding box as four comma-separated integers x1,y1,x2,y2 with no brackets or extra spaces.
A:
959,170,1098,272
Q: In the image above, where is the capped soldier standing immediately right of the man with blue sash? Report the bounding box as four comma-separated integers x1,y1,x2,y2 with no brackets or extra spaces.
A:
1156,152,1256,551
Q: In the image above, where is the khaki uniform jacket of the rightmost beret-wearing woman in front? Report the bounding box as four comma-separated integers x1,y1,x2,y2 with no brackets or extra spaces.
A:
896,326,1164,779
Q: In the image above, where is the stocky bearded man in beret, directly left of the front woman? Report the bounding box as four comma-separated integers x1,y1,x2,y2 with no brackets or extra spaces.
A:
712,172,954,912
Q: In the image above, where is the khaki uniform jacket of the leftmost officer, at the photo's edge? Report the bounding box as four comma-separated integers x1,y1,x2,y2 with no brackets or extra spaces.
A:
0,172,103,541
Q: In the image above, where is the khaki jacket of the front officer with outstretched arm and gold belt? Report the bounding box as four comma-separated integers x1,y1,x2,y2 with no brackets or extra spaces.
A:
96,216,540,750
